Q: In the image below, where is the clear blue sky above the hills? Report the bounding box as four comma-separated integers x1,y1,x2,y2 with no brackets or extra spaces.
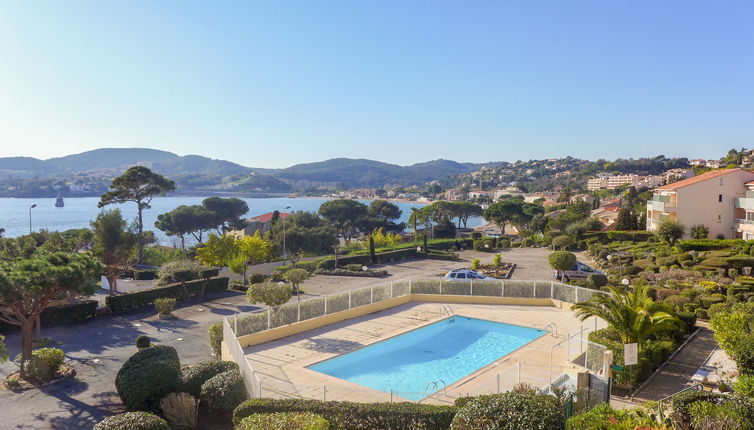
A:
0,0,754,167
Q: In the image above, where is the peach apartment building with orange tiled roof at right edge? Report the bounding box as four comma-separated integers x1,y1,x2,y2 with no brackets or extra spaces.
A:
647,168,754,240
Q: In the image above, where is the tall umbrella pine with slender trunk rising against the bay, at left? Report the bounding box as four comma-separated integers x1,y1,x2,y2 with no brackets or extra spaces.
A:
97,166,175,263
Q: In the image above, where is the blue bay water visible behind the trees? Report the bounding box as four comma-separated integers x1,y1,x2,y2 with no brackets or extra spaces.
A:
0,197,482,246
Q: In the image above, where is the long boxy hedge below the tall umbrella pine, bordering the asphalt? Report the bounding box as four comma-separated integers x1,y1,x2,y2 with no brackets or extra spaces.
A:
105,278,228,312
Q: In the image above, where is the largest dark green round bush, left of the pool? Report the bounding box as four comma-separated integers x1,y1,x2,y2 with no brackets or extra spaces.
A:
115,345,181,412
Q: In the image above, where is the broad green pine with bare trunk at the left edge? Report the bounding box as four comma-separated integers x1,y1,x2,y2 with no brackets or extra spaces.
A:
0,252,102,377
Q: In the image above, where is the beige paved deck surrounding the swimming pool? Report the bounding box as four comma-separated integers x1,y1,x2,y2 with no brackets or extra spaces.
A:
244,302,604,403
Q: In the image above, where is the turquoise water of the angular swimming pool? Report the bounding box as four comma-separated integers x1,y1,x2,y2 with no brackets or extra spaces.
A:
308,316,545,400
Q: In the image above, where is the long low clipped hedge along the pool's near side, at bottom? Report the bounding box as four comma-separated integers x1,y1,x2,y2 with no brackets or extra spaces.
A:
233,399,457,430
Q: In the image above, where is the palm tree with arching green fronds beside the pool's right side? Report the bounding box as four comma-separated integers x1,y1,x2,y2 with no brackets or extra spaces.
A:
572,285,683,346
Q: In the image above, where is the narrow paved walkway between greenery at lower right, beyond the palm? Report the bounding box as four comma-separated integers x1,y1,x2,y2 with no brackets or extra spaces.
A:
634,322,717,400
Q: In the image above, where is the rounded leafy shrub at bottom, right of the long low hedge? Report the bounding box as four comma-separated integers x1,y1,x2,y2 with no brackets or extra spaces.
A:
451,391,565,430
